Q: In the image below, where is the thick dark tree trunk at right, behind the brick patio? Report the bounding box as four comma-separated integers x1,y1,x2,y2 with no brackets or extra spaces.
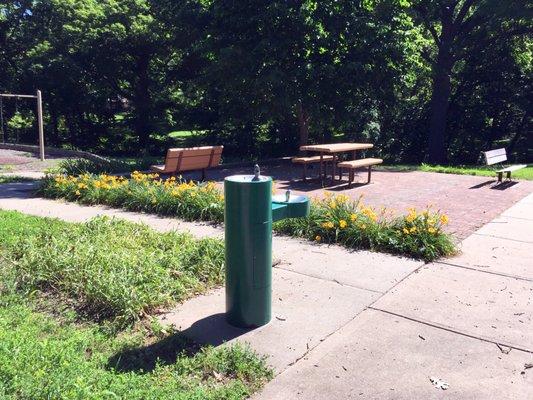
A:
428,44,453,164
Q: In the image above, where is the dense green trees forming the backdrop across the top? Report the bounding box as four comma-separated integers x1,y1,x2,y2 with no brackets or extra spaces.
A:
0,0,533,164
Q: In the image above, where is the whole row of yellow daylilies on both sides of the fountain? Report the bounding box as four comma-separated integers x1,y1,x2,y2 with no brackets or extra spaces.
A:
40,172,455,261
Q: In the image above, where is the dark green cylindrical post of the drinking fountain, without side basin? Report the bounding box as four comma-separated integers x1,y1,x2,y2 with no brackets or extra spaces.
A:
224,172,272,328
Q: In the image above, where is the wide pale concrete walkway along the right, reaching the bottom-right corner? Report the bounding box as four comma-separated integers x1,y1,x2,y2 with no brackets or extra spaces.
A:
254,195,533,400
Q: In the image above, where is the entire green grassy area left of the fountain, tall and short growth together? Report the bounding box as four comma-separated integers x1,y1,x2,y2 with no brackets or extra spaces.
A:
0,211,272,400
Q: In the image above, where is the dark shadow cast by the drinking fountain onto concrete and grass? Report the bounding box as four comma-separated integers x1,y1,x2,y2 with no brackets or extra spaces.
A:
107,313,251,373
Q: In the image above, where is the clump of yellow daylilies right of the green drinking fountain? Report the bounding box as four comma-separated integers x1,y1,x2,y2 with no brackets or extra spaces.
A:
274,195,455,261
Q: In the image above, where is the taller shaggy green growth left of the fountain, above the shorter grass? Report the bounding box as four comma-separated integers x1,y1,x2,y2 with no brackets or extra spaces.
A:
0,211,224,327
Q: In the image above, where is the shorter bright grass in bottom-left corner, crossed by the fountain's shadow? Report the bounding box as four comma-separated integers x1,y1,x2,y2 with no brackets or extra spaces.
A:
0,280,272,400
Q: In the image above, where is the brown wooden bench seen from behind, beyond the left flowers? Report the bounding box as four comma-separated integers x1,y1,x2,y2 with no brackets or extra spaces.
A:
150,146,224,180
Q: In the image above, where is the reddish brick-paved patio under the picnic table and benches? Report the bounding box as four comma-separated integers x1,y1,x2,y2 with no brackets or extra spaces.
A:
201,166,533,239
